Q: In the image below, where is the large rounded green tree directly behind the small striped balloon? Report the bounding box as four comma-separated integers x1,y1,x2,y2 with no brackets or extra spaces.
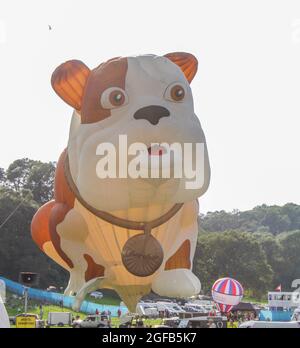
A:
194,231,273,297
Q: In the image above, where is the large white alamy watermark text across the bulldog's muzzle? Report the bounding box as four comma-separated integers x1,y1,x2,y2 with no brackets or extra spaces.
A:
96,134,205,190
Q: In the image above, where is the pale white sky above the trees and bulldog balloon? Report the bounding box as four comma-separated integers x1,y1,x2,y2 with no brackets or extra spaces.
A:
0,0,300,212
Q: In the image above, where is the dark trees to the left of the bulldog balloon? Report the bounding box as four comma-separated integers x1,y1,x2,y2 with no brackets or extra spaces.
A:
0,158,68,288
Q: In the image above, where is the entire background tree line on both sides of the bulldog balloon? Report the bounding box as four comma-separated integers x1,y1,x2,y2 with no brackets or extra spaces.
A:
0,158,300,298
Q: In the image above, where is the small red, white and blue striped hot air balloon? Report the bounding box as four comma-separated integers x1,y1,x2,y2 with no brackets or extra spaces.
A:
211,278,244,313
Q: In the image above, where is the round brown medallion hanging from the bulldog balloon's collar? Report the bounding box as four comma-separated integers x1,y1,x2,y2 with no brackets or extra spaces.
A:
122,234,164,277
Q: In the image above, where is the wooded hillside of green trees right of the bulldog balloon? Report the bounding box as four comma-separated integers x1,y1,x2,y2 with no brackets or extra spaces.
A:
194,203,300,298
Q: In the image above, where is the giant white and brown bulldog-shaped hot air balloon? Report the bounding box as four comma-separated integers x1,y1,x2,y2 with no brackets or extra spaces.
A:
32,52,210,311
